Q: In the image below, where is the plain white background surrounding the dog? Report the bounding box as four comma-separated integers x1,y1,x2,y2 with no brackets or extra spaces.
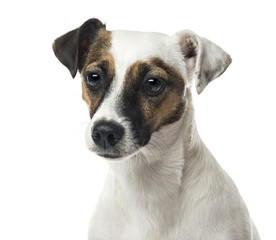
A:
0,0,276,240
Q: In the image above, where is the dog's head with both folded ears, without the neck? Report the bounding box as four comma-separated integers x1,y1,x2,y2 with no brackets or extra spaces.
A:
53,19,231,158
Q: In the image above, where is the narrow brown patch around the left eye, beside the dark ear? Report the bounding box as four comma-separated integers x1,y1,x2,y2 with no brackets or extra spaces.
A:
81,29,115,118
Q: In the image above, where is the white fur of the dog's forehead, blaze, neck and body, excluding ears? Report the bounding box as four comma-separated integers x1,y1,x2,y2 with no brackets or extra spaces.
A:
87,31,259,240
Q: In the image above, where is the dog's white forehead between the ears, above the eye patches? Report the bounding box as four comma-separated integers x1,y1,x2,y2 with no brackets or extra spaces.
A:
111,30,181,74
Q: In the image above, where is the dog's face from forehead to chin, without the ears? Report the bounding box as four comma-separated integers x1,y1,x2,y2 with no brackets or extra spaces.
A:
81,30,185,158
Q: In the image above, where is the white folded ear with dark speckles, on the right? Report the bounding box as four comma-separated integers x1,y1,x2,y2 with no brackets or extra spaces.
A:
176,30,232,94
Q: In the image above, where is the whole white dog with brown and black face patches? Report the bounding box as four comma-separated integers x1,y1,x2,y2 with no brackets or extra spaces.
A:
53,19,259,240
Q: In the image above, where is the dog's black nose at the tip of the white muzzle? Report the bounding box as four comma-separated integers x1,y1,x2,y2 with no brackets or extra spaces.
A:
92,121,125,149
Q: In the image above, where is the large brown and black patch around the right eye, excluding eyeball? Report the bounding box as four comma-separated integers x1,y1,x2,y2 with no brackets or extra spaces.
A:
123,57,185,145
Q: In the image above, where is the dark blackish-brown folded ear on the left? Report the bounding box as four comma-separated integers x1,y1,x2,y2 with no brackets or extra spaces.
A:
53,18,105,78
